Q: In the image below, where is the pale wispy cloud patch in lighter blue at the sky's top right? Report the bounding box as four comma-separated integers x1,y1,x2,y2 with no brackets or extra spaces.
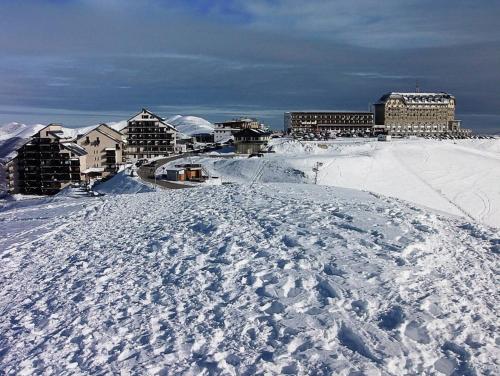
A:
229,0,500,48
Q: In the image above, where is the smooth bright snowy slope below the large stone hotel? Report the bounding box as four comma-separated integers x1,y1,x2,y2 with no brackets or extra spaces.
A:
179,139,500,227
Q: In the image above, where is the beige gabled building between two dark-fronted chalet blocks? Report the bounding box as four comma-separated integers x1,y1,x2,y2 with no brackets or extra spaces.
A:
76,124,126,180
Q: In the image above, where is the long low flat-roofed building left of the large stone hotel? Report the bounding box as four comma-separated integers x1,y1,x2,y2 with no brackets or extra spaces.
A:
284,111,374,135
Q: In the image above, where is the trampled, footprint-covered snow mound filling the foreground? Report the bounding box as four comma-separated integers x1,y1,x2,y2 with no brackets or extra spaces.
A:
0,184,500,375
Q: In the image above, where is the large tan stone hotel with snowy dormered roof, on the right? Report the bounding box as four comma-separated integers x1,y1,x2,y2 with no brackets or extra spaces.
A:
374,93,470,136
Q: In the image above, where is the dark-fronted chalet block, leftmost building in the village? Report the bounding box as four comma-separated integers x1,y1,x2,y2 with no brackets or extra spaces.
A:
13,124,87,195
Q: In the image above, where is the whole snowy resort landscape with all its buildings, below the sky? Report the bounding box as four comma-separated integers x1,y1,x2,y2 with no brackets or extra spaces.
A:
0,87,500,375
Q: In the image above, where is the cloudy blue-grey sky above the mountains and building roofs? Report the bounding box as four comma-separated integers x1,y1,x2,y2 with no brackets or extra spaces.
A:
0,0,500,132
